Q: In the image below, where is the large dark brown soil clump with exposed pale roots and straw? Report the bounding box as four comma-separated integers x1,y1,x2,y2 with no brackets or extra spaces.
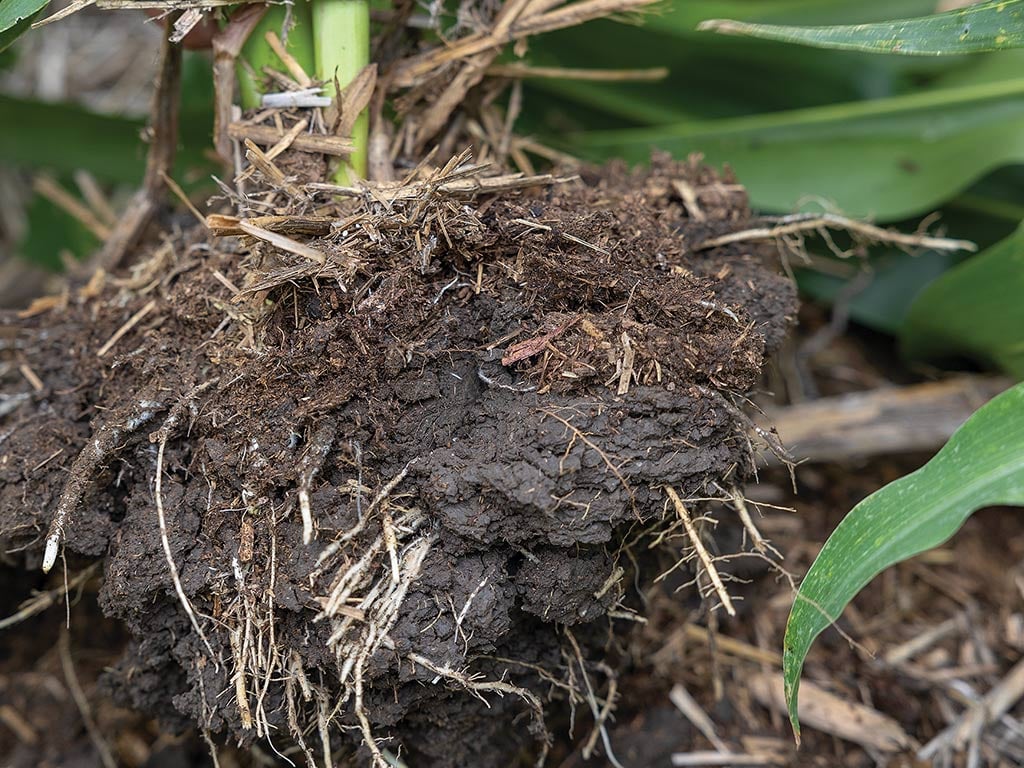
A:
0,156,795,766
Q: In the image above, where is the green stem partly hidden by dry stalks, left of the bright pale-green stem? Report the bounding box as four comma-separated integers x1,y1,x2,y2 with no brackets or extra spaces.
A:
237,0,314,110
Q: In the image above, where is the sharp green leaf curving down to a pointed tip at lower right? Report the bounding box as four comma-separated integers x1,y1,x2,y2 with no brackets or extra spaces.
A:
782,384,1024,738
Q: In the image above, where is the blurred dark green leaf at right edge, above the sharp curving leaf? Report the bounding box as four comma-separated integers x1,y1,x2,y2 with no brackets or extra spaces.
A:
901,225,1024,379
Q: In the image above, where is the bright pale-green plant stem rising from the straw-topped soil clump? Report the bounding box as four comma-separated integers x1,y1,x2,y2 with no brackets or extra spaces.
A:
312,0,370,183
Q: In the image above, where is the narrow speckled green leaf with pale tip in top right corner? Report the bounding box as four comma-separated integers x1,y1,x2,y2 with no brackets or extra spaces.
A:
697,0,1024,56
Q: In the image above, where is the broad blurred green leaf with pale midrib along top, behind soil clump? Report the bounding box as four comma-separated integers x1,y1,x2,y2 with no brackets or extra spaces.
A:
571,77,1024,220
